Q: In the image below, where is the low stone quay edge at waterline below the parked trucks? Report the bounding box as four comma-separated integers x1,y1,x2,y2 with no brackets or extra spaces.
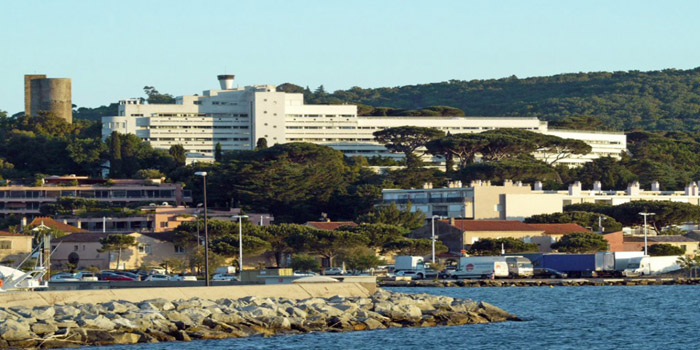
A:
377,277,700,288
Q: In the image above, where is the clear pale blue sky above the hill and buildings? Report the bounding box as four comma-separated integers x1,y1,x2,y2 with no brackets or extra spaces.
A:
0,0,700,114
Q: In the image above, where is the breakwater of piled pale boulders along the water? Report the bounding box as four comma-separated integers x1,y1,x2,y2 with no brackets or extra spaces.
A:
0,289,519,348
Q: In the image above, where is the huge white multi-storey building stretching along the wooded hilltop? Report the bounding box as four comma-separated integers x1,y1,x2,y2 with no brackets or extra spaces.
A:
102,75,626,165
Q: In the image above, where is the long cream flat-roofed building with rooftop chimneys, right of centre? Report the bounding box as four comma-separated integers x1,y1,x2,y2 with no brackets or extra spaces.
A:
379,180,700,220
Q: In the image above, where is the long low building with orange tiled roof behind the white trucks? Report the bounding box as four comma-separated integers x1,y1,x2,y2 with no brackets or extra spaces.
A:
409,218,544,253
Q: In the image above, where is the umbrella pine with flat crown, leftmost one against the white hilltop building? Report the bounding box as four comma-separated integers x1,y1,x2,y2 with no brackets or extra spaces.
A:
374,126,445,168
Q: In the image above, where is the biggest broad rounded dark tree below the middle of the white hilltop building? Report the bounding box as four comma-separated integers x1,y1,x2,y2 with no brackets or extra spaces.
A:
234,143,350,223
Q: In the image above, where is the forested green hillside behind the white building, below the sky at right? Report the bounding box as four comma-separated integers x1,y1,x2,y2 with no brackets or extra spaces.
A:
280,68,700,131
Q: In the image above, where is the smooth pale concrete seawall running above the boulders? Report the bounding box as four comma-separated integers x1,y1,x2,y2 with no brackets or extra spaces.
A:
0,282,377,308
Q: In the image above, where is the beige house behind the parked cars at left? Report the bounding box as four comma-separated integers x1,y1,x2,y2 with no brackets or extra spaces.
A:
51,232,185,269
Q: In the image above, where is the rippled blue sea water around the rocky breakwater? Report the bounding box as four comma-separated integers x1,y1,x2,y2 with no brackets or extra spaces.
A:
91,286,700,350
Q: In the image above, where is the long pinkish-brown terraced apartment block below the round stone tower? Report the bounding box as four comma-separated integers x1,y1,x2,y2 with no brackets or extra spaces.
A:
0,176,192,216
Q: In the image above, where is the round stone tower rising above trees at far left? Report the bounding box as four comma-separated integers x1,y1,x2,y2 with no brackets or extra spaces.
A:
29,78,73,123
